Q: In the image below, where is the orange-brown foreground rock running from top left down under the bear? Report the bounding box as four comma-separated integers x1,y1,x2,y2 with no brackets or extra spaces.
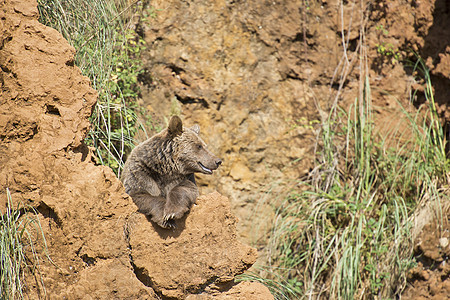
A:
0,0,271,299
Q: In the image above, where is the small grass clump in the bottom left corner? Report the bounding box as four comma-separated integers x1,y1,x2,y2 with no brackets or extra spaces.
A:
0,189,46,299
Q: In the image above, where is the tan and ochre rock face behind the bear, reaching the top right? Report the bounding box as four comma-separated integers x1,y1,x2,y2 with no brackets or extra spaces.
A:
138,0,450,246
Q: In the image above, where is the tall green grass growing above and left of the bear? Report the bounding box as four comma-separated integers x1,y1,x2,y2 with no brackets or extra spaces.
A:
38,0,150,175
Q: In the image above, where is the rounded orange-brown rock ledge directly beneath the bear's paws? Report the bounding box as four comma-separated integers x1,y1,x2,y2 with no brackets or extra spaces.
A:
128,192,268,299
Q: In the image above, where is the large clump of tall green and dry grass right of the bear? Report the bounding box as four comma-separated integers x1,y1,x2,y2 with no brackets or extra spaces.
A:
244,0,449,299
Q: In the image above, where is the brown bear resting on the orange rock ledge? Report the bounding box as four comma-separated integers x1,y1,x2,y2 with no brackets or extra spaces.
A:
120,116,222,228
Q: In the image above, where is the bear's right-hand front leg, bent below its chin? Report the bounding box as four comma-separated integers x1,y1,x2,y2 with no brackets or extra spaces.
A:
164,180,198,220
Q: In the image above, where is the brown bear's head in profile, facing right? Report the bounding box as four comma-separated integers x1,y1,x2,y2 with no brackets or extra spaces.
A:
167,116,222,174
